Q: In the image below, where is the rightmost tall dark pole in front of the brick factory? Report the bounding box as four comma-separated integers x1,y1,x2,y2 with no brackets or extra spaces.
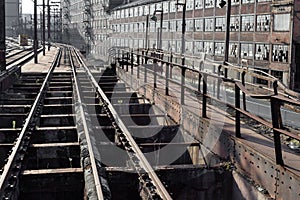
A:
223,0,231,78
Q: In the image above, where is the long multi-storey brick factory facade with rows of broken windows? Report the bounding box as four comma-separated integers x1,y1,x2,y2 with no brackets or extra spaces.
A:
65,0,300,90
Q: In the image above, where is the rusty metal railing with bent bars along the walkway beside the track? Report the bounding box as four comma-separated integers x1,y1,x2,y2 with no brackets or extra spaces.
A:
115,49,300,166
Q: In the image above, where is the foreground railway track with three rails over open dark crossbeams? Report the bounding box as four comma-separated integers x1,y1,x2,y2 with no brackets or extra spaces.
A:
0,47,218,199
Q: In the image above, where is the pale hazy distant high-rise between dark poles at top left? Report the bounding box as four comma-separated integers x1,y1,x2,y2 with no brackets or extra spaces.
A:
5,0,22,37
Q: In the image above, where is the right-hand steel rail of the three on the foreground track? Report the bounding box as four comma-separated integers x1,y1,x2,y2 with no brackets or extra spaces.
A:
76,48,172,200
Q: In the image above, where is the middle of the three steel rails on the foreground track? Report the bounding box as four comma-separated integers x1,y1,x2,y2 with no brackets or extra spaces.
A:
69,47,104,200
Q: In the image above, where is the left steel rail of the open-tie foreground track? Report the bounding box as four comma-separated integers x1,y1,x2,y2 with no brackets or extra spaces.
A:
0,47,61,199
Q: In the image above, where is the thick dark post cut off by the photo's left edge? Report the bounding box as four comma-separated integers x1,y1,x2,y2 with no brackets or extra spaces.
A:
0,1,6,72
